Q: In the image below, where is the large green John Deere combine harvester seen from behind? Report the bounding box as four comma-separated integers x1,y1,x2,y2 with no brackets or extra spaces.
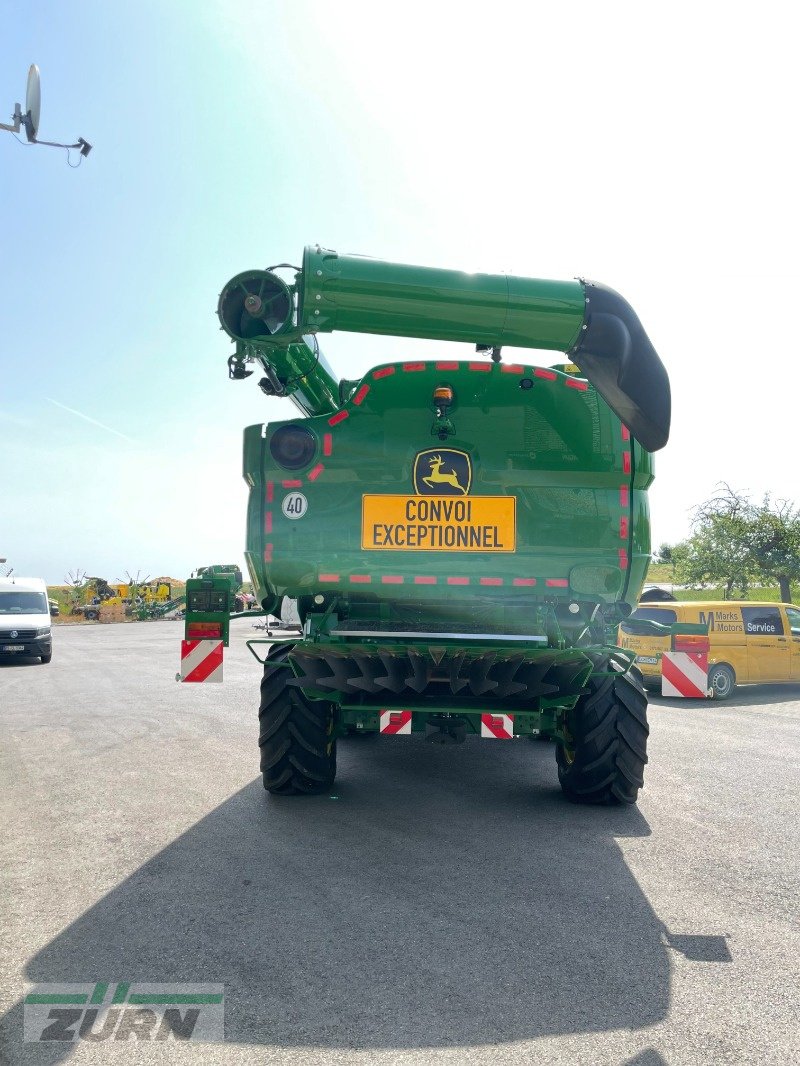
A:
187,247,670,803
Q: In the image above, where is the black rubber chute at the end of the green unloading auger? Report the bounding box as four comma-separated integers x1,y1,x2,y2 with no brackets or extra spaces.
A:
569,281,672,452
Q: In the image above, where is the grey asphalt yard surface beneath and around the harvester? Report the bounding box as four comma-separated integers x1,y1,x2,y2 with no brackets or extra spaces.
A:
0,619,800,1066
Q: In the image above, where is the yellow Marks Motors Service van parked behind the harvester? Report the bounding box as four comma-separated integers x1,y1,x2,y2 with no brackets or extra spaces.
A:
618,600,800,699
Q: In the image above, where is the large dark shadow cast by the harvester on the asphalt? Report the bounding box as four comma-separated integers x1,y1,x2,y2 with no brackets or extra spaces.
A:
5,737,682,1064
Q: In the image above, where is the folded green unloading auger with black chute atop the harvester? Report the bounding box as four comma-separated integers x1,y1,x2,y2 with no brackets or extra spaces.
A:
218,246,671,451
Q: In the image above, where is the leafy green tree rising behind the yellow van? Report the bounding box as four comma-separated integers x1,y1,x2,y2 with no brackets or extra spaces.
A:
673,482,800,602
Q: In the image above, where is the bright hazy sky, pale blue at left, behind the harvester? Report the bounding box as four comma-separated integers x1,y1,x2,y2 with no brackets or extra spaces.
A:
0,0,800,584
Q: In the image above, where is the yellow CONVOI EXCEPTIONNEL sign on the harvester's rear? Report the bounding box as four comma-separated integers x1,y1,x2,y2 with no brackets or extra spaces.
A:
362,496,516,551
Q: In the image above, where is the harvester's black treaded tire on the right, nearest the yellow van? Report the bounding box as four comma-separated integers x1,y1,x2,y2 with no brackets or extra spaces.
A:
556,657,650,804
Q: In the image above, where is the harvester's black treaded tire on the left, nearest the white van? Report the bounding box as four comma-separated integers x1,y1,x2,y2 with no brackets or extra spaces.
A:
258,644,336,796
